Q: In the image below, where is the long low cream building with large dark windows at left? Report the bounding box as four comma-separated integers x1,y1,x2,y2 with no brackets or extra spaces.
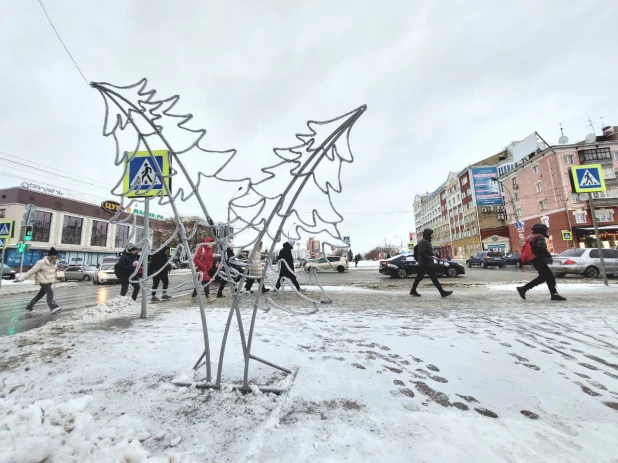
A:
0,187,161,267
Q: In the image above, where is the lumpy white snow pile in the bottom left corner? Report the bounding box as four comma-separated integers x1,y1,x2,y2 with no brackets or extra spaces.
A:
0,380,170,463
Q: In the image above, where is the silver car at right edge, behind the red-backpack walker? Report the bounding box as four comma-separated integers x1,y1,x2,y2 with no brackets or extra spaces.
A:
549,248,618,278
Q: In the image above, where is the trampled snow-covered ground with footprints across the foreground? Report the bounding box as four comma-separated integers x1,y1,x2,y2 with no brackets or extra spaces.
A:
0,285,618,463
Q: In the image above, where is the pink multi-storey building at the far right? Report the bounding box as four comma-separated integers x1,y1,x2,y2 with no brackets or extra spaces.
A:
500,130,618,253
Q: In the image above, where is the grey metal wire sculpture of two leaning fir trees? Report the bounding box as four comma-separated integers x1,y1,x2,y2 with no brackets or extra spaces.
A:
91,79,366,391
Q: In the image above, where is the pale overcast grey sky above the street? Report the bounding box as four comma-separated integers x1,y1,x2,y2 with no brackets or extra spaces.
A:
0,0,618,252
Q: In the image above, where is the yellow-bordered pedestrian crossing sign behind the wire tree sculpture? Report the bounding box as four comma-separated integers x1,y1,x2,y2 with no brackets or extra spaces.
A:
123,150,172,198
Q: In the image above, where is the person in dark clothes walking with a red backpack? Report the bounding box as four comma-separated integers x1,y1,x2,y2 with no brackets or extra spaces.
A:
517,223,566,301
